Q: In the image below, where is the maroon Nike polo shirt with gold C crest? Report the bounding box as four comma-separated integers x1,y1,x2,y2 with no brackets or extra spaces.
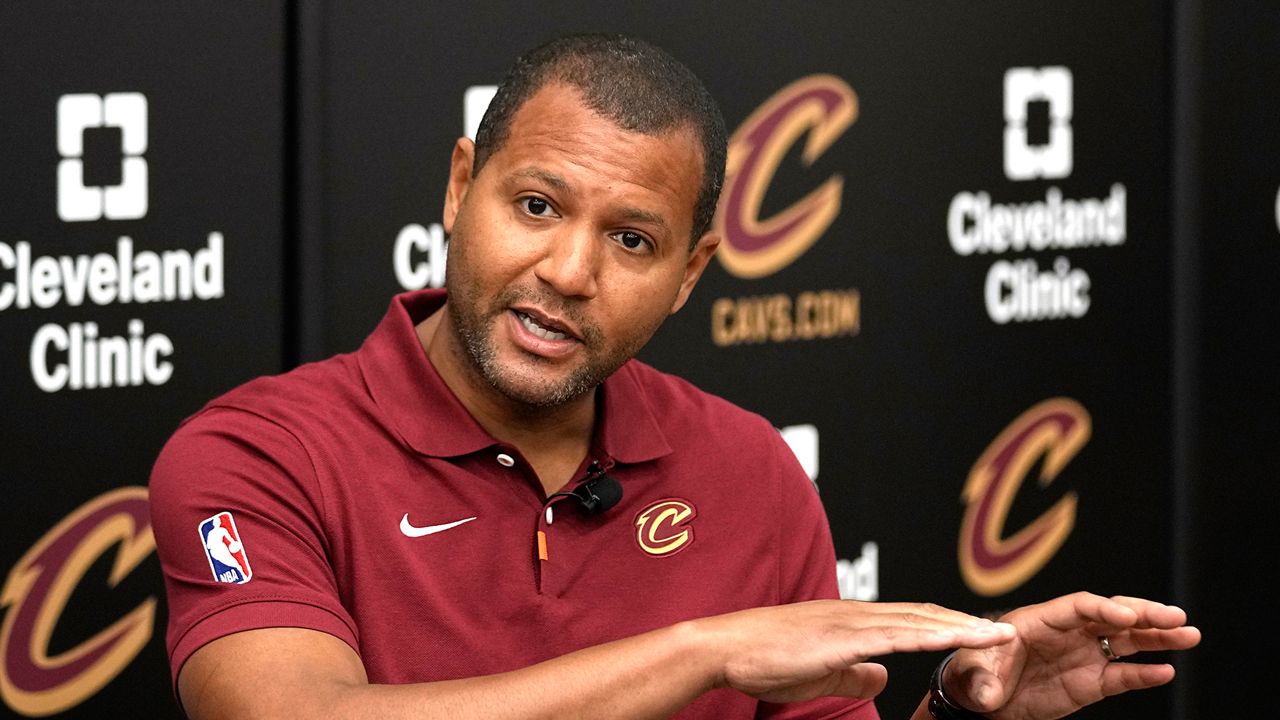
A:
151,291,877,719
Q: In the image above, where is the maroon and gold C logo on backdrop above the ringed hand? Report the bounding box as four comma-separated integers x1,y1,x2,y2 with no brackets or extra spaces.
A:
960,397,1092,597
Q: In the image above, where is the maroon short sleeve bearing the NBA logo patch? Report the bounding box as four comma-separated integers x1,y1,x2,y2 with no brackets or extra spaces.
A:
150,407,358,687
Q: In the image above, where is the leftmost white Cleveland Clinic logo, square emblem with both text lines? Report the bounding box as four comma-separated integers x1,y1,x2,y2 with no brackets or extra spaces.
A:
0,92,225,393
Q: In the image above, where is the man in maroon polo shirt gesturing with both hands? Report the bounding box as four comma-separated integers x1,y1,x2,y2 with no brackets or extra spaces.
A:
151,36,1199,720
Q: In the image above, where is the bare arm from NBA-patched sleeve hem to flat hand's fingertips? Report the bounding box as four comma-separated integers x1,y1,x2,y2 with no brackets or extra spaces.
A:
178,600,1012,720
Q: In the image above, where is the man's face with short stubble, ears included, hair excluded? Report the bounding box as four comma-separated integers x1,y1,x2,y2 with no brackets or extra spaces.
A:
444,85,716,407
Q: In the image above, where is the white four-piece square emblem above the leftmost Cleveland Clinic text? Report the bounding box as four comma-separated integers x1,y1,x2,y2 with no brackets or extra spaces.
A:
58,92,147,223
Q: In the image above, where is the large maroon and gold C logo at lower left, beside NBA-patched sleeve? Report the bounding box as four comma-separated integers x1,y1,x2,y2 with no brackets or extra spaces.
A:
0,487,156,716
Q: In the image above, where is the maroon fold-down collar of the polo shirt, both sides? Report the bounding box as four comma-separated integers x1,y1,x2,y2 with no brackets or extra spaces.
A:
356,290,671,462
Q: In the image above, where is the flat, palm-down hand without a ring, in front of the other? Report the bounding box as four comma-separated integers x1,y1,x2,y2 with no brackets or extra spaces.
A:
694,600,1015,702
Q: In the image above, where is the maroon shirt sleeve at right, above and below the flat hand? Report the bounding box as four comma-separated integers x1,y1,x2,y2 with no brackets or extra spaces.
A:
755,425,879,720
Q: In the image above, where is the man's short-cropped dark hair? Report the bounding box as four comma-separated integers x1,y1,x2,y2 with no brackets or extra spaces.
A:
471,35,728,247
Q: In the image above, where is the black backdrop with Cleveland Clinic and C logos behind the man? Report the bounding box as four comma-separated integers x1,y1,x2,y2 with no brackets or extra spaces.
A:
0,0,1280,719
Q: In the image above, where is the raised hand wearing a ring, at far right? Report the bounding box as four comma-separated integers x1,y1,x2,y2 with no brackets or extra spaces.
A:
942,592,1201,720
